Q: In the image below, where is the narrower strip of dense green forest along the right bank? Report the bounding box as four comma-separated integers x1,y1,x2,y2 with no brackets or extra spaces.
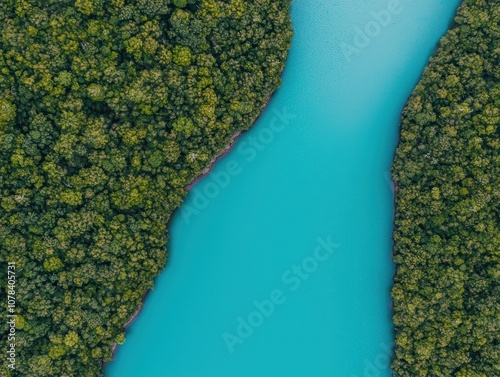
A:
393,0,500,377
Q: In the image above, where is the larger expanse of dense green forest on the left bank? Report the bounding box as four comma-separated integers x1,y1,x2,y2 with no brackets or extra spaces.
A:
0,0,292,377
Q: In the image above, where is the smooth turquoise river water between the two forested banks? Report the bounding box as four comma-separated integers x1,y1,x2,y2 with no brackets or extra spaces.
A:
106,0,459,377
